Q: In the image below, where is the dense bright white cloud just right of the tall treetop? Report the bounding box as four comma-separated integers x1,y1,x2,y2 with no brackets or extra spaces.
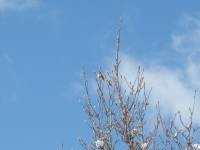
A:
121,55,200,122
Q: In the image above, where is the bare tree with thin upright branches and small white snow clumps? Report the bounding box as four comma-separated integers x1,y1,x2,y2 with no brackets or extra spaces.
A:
80,24,200,150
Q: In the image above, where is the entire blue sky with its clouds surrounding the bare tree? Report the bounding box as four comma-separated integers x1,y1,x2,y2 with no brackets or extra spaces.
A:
0,0,200,150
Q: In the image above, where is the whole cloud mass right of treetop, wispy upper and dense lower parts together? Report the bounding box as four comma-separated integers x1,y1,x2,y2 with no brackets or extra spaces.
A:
118,15,200,123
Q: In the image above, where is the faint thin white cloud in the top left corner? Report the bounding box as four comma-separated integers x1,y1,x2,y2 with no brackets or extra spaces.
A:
0,0,39,12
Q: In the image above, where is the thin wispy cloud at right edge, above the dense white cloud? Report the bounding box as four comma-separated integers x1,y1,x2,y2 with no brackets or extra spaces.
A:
172,15,200,89
